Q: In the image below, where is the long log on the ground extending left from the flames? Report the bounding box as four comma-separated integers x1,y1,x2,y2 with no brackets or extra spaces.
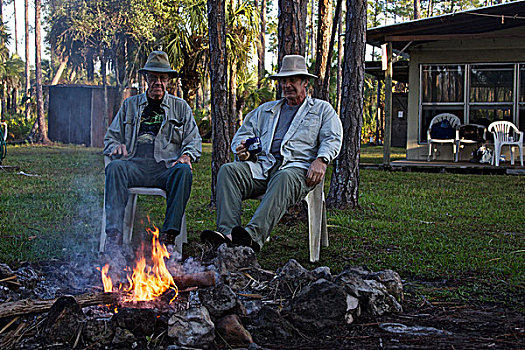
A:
0,293,118,318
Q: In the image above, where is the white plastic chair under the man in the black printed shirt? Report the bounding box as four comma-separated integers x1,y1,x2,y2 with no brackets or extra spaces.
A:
99,156,188,254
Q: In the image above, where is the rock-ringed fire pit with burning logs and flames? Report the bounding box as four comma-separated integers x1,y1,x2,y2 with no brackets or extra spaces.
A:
0,228,403,349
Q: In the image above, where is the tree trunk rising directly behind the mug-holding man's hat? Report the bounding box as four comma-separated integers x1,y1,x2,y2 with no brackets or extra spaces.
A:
277,0,307,98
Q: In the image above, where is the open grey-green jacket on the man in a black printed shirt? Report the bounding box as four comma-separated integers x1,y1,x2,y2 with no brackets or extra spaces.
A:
104,92,202,167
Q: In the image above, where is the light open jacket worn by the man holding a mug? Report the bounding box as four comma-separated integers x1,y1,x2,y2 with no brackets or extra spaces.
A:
231,97,343,180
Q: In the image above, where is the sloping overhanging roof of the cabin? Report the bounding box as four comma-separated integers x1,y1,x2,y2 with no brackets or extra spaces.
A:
366,1,525,50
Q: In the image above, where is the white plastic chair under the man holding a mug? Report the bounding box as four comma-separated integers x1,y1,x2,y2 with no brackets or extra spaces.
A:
254,178,329,262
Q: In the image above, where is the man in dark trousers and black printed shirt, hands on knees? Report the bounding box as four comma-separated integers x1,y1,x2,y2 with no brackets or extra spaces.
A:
104,51,201,247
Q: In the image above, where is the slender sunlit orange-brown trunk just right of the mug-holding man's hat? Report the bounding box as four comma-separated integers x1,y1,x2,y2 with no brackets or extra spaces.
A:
313,0,332,101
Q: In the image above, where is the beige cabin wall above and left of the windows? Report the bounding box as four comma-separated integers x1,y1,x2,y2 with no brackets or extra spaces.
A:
407,26,525,160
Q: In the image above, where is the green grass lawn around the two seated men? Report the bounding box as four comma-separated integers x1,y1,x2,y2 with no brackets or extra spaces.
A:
0,144,525,308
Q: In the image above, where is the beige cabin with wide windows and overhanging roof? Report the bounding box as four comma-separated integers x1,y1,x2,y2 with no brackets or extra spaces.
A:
366,1,525,161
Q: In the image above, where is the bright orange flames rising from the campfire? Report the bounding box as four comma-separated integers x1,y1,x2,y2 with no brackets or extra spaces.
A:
102,226,178,303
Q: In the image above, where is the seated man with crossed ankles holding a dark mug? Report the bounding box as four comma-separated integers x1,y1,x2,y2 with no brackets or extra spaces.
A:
201,55,342,251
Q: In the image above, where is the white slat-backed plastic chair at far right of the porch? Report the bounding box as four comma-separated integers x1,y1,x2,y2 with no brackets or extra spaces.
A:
488,121,523,166
